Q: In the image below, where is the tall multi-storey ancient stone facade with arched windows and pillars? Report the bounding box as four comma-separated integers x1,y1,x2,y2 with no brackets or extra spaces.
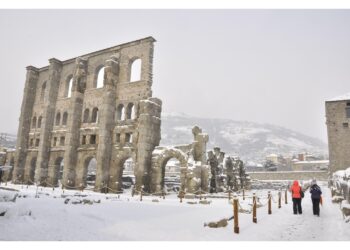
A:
12,37,162,191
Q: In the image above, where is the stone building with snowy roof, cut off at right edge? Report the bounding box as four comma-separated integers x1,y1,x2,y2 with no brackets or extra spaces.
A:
325,94,350,173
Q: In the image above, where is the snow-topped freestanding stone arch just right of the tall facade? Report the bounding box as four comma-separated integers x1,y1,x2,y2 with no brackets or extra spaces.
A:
151,148,188,192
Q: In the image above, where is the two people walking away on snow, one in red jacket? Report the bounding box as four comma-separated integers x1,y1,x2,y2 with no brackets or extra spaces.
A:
290,179,322,216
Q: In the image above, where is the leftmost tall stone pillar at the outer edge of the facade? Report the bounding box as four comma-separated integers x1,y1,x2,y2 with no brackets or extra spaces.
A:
12,66,39,183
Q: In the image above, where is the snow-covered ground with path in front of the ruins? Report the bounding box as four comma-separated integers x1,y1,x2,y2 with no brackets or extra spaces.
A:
0,184,350,241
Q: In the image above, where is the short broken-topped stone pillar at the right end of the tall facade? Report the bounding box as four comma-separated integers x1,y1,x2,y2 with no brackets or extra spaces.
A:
135,98,162,192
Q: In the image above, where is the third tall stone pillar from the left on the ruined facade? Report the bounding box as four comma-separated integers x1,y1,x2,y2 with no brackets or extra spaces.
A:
63,58,87,186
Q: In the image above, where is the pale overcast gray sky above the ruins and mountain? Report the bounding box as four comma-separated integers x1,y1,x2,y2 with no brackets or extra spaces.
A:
0,10,350,141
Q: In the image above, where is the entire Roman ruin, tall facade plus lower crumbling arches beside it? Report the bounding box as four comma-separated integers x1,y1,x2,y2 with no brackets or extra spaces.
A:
0,37,249,193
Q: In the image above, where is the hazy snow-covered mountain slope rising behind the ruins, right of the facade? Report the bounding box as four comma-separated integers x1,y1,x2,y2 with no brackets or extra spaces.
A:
161,114,327,160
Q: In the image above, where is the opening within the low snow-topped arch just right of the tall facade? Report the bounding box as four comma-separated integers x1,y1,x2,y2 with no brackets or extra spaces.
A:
161,158,181,192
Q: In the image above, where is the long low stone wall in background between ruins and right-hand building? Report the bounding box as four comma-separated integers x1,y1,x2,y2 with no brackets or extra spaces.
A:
247,171,328,181
